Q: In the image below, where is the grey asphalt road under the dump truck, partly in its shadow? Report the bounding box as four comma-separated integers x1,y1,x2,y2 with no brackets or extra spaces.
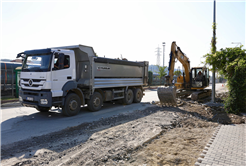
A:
0,84,227,145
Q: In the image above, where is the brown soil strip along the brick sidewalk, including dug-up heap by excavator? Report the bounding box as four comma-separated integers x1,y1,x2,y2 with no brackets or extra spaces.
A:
125,93,245,166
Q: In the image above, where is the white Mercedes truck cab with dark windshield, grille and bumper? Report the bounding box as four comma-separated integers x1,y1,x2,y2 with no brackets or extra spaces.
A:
19,49,76,110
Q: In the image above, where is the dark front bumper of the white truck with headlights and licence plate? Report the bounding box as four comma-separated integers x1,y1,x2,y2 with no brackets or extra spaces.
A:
19,89,52,108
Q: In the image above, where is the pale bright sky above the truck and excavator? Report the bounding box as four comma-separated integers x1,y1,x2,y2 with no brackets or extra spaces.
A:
0,0,246,68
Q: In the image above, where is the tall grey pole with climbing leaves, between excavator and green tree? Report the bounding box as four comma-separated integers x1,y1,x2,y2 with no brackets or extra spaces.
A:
212,0,216,103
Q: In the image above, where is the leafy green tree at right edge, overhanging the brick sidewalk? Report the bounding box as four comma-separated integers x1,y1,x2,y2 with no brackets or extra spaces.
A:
204,46,246,114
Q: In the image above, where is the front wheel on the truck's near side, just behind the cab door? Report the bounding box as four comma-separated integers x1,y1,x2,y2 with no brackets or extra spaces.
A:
62,93,81,116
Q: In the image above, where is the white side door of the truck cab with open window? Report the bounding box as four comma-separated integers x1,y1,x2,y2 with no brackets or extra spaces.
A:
51,53,75,97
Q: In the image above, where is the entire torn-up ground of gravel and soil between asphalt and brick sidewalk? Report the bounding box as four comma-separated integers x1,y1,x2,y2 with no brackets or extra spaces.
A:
0,91,245,166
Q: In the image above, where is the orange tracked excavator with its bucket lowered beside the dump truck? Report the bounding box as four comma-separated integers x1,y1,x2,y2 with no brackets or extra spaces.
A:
157,42,211,105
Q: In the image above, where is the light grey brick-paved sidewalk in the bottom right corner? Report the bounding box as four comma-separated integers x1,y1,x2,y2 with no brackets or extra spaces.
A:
195,124,246,166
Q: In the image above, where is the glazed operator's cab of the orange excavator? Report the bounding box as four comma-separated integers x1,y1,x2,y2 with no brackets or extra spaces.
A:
190,67,209,89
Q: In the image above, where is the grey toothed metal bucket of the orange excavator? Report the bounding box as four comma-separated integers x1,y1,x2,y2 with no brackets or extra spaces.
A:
157,86,177,106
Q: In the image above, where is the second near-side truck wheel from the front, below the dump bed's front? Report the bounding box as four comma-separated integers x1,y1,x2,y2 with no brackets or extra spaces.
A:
87,92,103,112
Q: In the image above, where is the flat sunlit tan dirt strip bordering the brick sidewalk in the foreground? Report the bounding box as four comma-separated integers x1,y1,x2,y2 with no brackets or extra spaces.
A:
125,117,218,166
